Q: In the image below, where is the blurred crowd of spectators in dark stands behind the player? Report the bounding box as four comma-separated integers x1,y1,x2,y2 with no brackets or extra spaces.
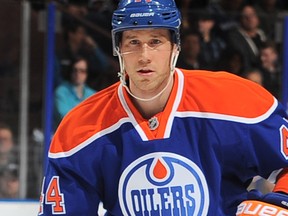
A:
0,0,288,199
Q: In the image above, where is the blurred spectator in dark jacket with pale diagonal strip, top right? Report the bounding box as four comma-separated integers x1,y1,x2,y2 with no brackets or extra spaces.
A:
227,5,266,69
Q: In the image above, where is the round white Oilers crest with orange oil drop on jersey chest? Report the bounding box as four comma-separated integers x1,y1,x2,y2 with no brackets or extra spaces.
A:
118,152,209,216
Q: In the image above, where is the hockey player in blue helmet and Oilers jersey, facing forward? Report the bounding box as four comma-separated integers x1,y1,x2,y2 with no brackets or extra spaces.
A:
39,0,288,216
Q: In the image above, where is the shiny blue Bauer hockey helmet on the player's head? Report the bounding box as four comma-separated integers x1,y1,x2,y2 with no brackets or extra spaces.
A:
112,0,181,55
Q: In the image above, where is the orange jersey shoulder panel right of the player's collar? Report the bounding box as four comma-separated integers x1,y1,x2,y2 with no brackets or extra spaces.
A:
182,70,276,118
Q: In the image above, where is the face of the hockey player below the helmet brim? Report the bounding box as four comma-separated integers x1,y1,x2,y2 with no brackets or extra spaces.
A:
120,29,173,96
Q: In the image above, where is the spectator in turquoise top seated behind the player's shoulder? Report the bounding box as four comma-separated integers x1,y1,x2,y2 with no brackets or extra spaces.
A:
54,56,96,127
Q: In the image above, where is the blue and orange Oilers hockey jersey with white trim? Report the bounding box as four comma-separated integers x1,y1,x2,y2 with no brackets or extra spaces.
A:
39,69,288,216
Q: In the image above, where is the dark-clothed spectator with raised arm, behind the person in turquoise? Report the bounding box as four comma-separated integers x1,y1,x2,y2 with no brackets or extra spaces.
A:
56,20,111,89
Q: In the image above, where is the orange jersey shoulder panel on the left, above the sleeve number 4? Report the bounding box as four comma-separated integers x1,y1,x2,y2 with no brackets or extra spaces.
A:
50,83,126,153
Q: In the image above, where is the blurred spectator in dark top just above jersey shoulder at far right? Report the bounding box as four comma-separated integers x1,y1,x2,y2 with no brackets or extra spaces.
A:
259,41,282,99
